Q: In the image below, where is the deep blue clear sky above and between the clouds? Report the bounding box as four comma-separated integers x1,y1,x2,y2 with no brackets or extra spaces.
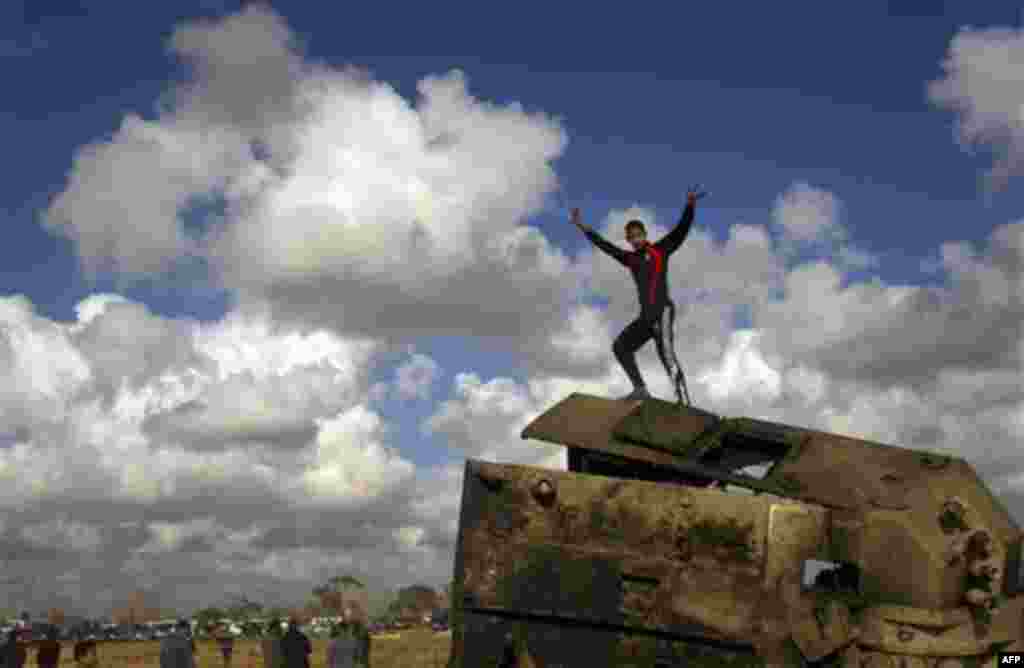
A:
6,2,1024,459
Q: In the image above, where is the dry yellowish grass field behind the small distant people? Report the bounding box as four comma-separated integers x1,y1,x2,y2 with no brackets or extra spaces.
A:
18,629,452,668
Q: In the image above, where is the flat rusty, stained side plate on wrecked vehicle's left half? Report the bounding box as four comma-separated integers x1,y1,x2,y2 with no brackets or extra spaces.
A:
456,462,824,642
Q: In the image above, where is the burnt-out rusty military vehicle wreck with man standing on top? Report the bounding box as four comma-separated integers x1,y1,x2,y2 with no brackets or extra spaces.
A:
449,393,1024,668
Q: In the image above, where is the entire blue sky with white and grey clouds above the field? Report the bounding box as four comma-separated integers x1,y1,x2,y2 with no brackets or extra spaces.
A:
0,0,1024,614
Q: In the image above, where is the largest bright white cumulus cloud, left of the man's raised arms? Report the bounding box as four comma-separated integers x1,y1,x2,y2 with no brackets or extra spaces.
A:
43,5,568,339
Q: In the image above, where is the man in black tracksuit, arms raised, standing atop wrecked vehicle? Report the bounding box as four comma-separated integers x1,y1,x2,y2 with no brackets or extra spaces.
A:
571,189,703,404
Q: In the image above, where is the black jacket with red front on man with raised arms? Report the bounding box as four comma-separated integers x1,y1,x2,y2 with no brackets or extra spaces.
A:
586,204,694,318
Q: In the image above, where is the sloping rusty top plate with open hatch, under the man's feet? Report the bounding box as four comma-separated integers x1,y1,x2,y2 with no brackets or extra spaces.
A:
522,393,1019,528
